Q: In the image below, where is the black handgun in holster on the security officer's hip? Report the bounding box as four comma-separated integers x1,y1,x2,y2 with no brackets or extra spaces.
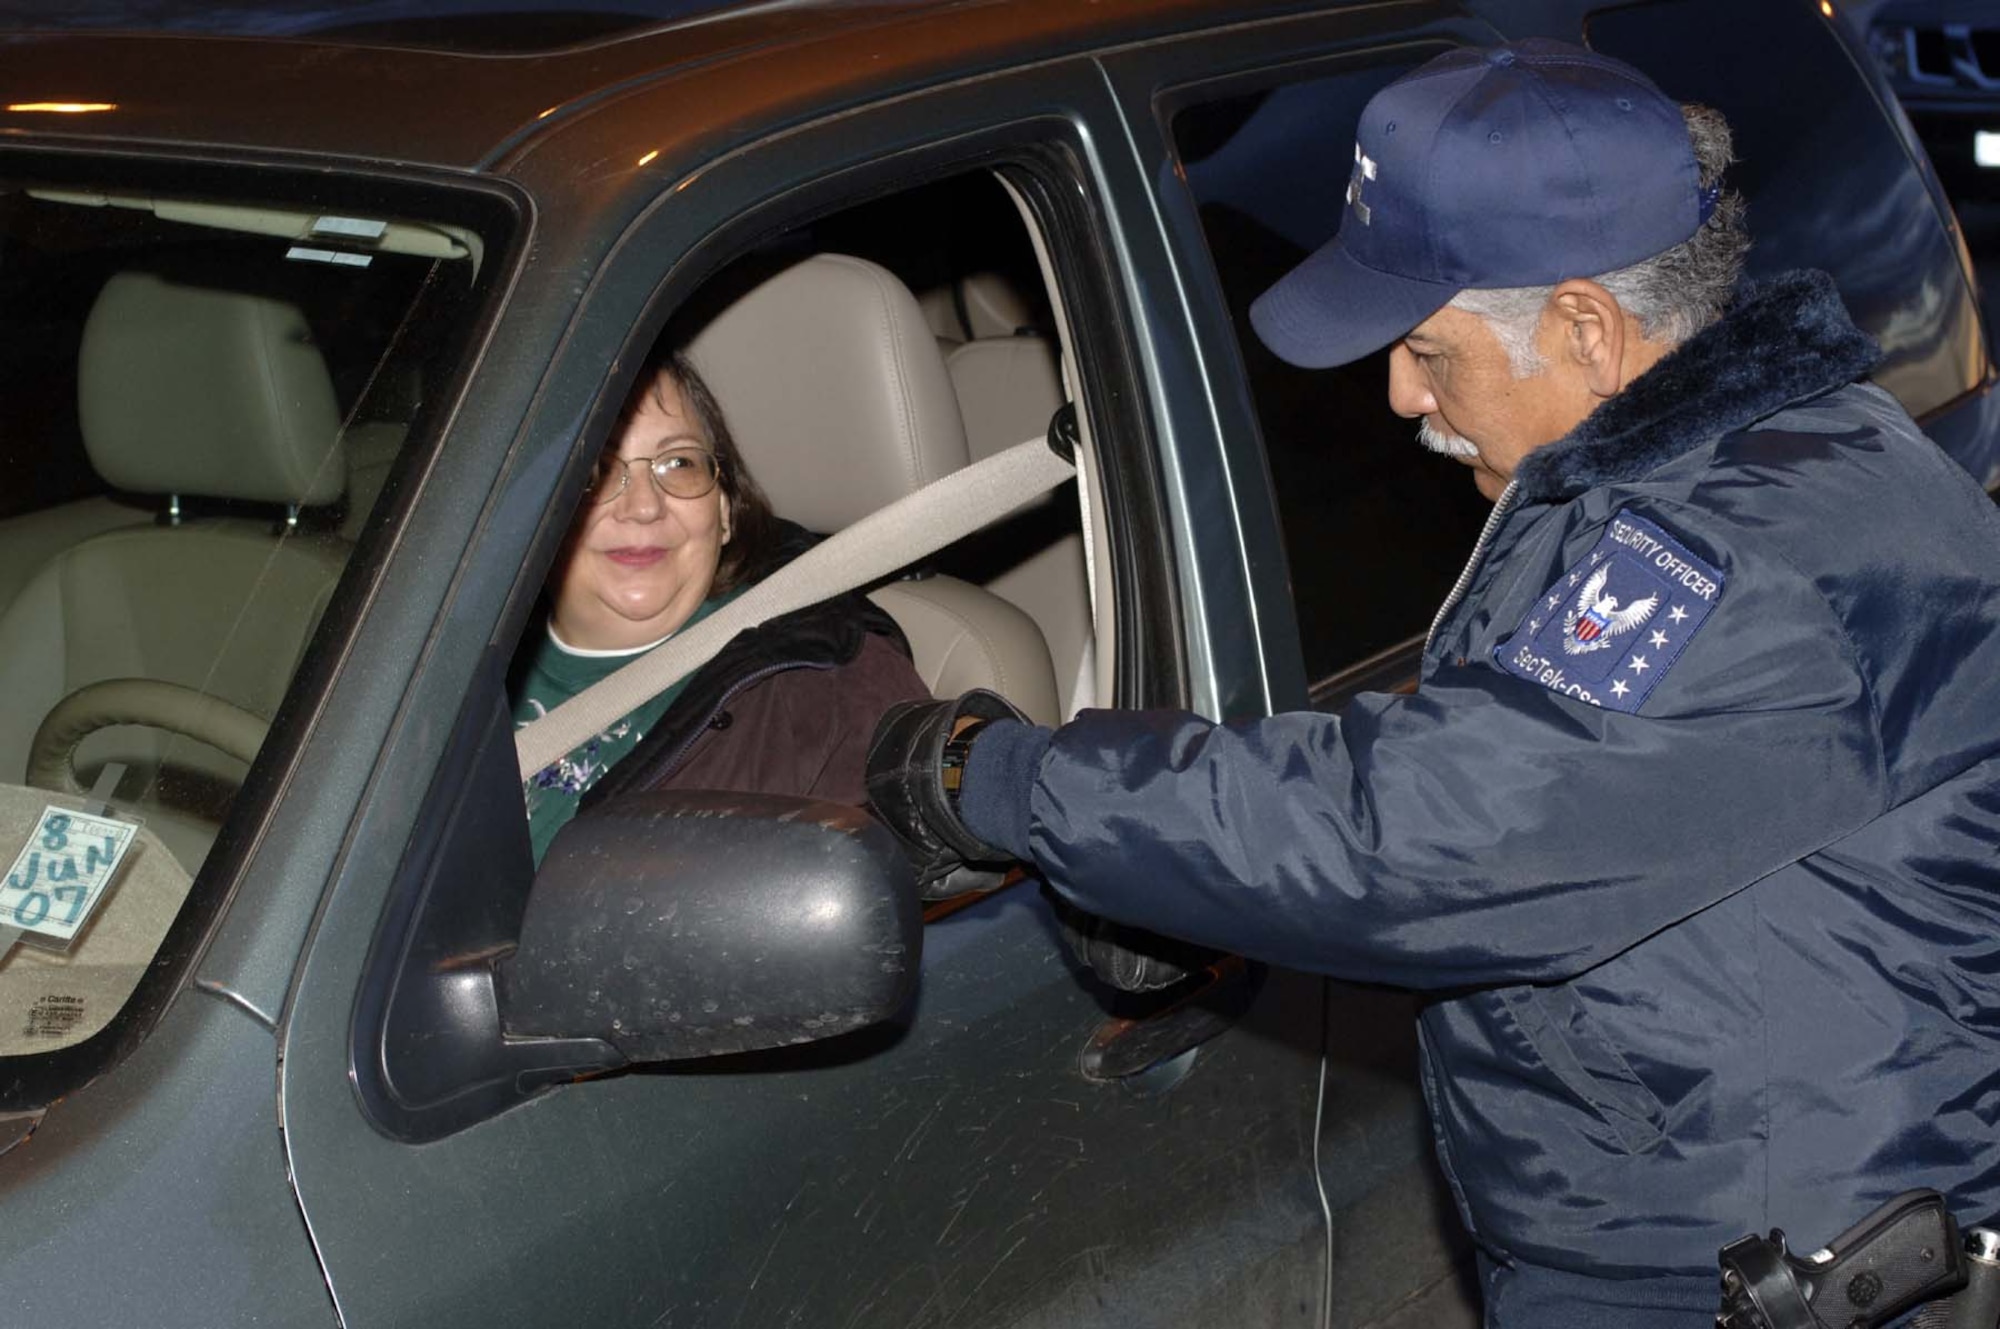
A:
1716,1191,2000,1329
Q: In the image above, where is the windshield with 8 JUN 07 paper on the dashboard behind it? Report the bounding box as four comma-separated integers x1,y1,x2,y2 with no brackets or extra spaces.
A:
0,180,482,1057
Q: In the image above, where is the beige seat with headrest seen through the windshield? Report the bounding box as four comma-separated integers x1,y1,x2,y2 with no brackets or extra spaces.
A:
0,272,348,869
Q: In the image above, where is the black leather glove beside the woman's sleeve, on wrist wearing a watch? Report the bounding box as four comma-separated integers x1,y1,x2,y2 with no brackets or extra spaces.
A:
868,689,1028,901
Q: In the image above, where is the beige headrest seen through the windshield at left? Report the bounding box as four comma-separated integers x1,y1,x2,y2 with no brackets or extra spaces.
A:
76,272,348,506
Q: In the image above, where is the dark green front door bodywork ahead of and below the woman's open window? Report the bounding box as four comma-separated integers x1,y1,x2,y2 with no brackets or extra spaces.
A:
284,52,1344,1325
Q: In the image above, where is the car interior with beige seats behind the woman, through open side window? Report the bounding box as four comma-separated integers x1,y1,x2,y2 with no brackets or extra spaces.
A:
640,174,1098,725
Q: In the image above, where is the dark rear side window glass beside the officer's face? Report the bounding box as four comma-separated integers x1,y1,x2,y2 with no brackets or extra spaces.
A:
1172,64,1490,703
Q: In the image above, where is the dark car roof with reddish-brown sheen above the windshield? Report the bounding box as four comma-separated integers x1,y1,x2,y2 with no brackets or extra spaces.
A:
0,0,1320,170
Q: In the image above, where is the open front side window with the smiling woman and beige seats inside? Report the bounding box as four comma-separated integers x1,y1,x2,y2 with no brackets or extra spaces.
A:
510,174,1094,872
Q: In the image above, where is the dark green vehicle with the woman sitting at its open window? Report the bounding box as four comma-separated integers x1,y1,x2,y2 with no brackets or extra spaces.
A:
0,0,2000,1329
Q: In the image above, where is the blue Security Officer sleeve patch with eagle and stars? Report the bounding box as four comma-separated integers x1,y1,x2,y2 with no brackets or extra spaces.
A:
1494,510,1722,713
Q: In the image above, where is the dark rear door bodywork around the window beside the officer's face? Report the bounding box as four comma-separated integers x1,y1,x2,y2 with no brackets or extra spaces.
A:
1102,4,1498,1325
